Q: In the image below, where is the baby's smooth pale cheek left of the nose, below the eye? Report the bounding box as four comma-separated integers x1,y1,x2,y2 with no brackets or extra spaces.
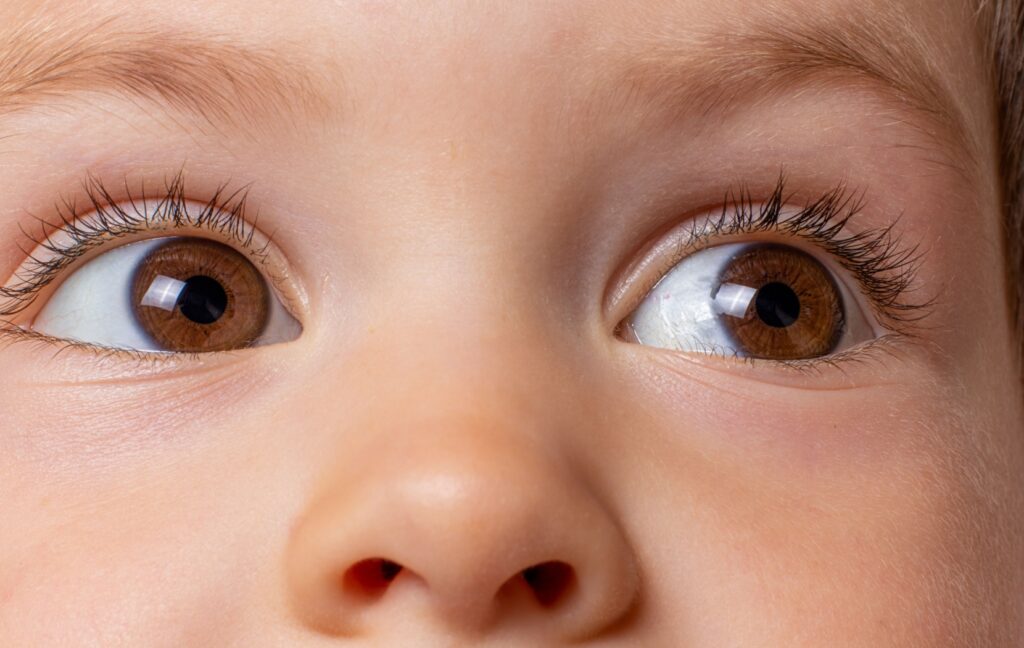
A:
0,386,305,646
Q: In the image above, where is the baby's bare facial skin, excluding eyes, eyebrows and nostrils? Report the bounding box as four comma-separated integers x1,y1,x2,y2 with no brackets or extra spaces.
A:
0,0,1024,646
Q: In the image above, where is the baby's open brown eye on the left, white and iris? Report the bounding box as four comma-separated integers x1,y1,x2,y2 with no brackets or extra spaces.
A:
30,236,302,353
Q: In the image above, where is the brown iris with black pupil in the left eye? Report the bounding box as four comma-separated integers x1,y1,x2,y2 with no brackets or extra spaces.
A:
131,239,270,353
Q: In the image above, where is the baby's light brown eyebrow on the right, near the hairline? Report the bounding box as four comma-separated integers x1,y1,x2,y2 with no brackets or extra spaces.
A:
606,10,980,161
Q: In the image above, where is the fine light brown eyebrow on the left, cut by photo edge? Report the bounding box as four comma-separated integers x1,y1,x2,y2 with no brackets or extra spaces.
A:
0,19,326,125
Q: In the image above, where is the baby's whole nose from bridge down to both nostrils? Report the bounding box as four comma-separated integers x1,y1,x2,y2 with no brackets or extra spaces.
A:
287,159,638,643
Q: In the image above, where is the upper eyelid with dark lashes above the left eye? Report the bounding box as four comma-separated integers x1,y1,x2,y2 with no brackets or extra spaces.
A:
0,171,307,319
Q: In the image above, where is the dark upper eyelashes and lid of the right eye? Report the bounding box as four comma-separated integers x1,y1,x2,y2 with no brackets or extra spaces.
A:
658,175,934,334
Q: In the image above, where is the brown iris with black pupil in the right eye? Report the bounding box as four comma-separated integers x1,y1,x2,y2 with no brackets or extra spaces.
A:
716,245,844,360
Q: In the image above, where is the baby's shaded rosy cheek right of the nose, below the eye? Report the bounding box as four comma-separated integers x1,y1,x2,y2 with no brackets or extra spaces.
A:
598,366,1024,646
